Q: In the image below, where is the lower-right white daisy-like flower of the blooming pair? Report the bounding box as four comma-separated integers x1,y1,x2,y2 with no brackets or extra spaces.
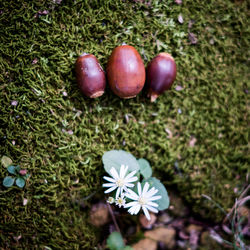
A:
124,182,161,220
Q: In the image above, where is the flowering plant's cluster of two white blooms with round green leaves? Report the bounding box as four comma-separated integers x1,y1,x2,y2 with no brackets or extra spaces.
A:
102,150,169,220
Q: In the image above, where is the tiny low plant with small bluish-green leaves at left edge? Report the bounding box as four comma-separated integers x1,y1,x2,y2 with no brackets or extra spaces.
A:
2,156,30,188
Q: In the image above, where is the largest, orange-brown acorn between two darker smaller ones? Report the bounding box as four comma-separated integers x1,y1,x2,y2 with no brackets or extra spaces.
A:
107,45,146,99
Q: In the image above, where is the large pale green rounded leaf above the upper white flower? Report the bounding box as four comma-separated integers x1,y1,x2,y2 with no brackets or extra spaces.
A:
102,150,140,173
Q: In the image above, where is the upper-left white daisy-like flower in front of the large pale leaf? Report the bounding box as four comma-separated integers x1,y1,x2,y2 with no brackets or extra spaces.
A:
102,165,138,199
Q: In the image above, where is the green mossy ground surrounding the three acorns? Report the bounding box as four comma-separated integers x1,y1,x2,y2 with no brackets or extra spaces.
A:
0,0,250,249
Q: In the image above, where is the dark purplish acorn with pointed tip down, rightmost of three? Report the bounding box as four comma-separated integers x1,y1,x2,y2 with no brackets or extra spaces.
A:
147,53,176,102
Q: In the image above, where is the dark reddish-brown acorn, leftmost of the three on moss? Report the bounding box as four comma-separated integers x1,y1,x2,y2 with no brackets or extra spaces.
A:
75,53,106,98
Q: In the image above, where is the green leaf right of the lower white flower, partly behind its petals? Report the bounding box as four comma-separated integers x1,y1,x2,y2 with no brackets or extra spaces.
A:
142,177,169,210
